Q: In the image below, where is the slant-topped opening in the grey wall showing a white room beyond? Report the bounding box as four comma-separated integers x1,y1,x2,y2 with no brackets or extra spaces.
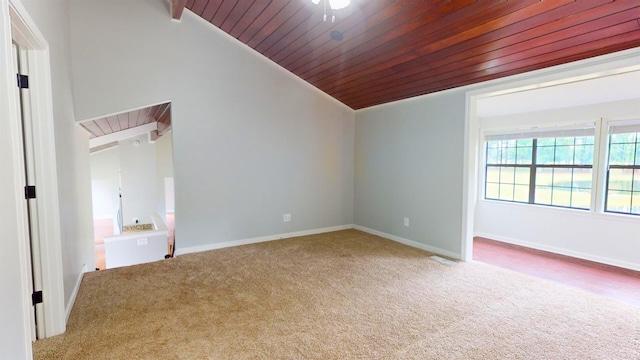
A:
80,102,175,270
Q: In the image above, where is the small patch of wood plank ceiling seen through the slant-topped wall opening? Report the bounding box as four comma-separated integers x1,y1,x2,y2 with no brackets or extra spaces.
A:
80,103,171,139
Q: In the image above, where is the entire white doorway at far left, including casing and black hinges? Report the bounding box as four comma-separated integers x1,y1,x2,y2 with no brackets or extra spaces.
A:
0,0,66,352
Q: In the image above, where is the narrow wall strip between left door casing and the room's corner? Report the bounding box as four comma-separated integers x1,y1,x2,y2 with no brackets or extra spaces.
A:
22,0,95,320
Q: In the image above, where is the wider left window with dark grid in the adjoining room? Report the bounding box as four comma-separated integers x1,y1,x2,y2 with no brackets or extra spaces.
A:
485,127,596,209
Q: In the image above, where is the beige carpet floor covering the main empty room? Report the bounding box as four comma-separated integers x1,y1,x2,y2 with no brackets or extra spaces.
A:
34,230,640,360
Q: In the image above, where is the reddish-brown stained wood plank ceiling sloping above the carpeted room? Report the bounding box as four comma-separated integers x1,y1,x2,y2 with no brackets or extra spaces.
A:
186,0,640,109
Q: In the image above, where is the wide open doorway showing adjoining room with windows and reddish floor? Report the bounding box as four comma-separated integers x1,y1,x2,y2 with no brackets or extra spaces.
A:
463,50,640,305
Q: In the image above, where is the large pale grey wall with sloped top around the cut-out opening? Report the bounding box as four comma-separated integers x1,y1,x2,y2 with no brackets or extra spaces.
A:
71,0,354,248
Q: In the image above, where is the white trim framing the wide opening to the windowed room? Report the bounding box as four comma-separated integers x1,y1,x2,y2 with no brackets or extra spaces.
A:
461,48,640,261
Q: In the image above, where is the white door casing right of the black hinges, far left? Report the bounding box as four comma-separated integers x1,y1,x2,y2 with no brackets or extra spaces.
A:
8,0,66,337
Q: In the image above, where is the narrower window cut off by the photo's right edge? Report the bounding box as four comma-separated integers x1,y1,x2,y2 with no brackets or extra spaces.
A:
605,126,640,215
